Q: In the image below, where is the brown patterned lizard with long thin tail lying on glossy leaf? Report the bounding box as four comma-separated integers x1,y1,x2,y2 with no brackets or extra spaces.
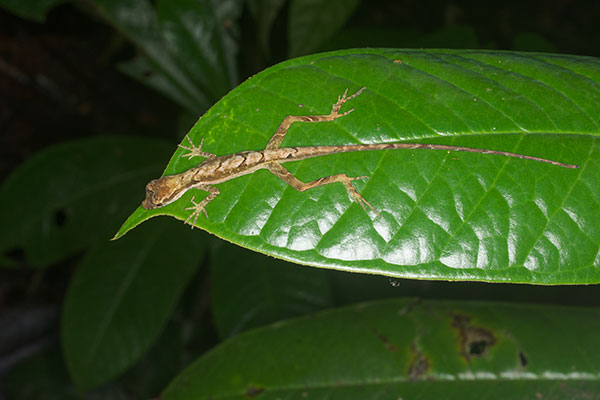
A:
142,87,578,228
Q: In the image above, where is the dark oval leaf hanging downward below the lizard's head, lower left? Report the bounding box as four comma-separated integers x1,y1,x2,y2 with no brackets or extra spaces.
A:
62,217,205,388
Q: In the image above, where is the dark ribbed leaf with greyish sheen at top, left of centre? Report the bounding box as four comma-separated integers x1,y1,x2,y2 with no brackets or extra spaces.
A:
94,0,242,113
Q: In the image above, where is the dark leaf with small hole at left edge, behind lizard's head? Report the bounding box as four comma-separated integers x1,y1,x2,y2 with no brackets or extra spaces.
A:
0,137,172,267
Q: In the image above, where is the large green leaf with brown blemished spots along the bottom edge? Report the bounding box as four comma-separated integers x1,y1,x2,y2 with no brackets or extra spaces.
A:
161,299,600,400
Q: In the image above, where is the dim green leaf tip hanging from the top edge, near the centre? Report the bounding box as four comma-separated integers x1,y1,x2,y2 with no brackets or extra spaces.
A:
288,0,360,57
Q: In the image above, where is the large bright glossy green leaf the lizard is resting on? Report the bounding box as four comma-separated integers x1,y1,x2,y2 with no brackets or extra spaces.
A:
117,49,600,284
